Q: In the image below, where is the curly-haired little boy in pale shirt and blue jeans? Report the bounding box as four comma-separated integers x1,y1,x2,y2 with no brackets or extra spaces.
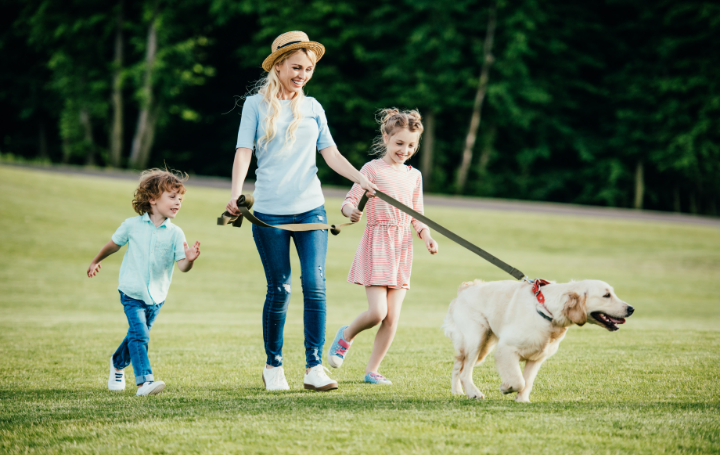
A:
87,169,200,396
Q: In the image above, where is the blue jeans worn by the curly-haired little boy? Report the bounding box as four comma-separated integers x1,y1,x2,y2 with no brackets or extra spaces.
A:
113,292,165,385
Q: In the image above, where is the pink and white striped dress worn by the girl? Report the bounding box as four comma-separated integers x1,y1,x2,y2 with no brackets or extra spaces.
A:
341,159,427,289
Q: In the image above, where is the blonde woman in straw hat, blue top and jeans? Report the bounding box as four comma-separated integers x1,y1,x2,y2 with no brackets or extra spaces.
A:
227,31,375,391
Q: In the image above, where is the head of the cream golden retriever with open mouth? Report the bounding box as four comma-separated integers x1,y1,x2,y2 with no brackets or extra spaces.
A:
562,280,635,332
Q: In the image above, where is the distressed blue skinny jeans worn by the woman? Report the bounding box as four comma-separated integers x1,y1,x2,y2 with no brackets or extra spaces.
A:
253,205,328,368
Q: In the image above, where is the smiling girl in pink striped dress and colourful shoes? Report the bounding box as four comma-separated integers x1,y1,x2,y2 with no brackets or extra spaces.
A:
328,109,438,384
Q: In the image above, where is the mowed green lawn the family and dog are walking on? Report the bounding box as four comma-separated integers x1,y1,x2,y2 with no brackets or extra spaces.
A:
0,167,720,454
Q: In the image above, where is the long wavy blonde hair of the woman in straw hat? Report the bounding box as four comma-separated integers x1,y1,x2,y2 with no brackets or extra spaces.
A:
255,48,317,149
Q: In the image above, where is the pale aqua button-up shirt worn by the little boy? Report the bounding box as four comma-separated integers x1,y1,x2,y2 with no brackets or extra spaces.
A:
112,213,185,305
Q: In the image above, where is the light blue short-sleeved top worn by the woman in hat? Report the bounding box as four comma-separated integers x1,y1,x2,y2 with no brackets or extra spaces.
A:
236,94,335,215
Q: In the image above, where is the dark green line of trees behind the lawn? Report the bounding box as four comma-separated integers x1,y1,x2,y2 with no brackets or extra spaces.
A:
0,0,720,215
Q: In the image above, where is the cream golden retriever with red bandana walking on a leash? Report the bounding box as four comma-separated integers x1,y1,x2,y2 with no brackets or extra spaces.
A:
443,280,635,403
